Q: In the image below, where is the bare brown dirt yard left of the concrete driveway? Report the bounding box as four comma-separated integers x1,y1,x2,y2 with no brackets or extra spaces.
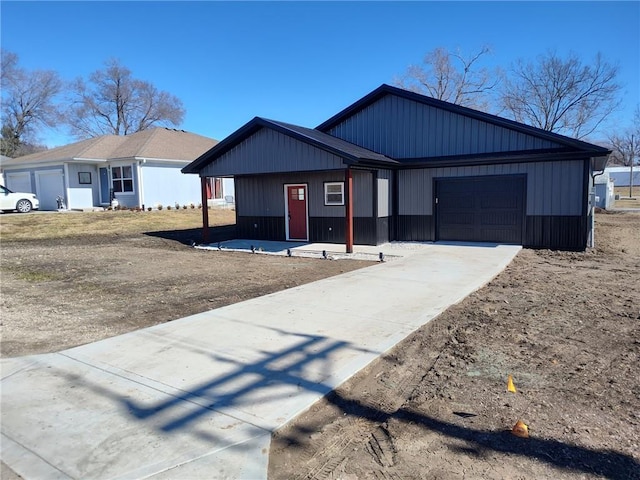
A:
0,213,372,357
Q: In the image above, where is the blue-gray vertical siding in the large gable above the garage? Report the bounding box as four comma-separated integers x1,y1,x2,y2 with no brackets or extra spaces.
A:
327,95,561,159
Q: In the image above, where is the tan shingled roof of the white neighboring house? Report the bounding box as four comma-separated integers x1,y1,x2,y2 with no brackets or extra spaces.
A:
3,128,218,166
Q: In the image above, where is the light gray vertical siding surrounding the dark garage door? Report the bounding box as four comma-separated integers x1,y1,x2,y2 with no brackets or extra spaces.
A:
398,160,585,215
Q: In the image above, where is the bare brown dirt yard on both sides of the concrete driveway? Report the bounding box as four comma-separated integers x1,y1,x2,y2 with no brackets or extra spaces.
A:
0,212,640,480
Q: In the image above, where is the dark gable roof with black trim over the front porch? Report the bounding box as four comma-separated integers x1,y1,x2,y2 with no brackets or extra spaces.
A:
182,117,398,173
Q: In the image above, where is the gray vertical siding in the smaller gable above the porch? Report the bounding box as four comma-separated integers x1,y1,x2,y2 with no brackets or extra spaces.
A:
200,128,346,177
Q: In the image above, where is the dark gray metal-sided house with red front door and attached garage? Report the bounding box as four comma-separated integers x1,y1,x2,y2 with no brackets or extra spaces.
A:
182,85,611,251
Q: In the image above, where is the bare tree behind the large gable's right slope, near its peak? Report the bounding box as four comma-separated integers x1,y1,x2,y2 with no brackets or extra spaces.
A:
394,46,501,110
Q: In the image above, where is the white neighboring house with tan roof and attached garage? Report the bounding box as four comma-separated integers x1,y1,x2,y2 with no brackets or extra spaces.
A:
0,128,234,210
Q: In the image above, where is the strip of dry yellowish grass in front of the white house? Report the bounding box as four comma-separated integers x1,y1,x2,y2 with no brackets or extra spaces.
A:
0,208,235,242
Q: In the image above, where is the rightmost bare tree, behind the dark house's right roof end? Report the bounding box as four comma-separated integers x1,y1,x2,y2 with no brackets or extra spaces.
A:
501,52,620,138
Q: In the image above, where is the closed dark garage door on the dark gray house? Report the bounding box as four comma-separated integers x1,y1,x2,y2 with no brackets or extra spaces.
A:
436,175,525,244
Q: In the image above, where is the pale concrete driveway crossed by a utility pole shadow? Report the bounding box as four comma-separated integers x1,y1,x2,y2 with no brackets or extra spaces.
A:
1,244,520,480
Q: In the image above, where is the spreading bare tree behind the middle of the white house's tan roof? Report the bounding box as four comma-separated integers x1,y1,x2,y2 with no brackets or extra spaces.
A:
67,59,185,138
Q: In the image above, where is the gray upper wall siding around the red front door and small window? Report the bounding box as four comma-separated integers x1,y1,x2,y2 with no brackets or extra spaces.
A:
235,170,373,217
